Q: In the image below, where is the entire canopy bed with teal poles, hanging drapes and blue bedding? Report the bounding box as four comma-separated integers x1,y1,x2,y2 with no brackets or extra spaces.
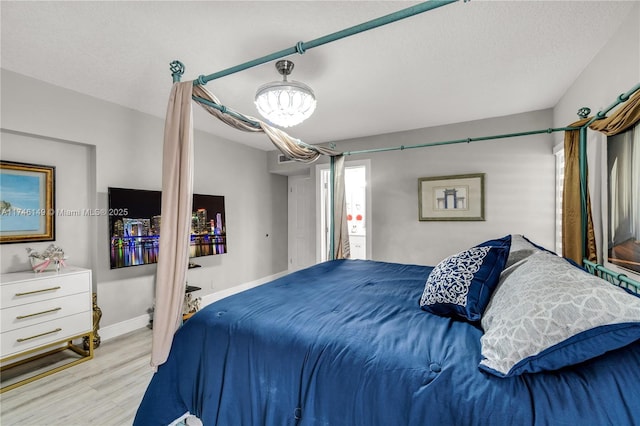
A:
139,1,640,425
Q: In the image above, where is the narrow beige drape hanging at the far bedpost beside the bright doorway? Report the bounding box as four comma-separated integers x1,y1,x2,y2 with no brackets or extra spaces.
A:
333,155,351,259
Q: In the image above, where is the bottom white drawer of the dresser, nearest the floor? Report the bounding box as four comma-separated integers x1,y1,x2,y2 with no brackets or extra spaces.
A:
1,311,92,358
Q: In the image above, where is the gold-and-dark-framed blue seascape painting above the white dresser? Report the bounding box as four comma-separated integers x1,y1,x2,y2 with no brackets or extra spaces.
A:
0,160,56,244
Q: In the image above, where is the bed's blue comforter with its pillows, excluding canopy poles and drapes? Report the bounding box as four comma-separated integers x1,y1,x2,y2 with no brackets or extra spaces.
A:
134,235,640,426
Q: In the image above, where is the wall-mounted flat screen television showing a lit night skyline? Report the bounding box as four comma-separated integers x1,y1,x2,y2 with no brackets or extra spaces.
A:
108,187,227,269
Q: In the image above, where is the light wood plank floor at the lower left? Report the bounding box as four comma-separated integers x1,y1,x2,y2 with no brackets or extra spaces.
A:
0,328,153,426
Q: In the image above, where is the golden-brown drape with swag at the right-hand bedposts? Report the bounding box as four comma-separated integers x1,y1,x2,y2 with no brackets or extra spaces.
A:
562,92,640,265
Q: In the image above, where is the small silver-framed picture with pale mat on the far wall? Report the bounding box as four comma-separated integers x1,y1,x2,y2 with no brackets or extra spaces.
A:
418,173,485,221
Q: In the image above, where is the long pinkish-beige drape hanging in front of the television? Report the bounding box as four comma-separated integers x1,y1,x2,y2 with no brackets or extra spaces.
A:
151,81,193,368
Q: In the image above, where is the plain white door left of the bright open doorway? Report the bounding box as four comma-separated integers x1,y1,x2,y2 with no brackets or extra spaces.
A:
288,176,316,271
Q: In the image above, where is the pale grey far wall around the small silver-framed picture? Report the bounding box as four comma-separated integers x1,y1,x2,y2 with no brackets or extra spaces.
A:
270,110,555,265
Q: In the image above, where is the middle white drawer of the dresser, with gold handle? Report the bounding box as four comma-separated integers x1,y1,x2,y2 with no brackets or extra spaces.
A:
1,292,91,333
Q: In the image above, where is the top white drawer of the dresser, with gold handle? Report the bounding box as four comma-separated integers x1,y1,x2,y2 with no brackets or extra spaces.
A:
0,270,91,310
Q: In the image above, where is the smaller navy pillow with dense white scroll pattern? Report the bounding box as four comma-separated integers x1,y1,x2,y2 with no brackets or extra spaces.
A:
420,235,511,321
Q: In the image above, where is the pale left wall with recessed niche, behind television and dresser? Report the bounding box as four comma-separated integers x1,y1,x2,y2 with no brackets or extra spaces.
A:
0,70,287,326
